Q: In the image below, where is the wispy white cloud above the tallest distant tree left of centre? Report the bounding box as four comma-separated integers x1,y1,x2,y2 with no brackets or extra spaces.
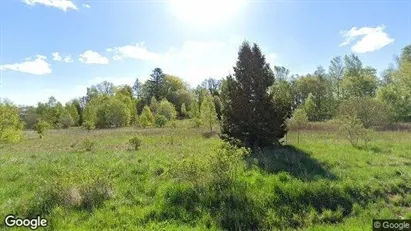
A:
107,43,161,60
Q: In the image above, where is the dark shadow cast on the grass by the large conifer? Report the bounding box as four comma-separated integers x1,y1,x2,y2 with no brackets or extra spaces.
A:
247,145,337,181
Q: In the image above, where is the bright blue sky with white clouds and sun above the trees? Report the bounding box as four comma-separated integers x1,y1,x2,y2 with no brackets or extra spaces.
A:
0,0,411,105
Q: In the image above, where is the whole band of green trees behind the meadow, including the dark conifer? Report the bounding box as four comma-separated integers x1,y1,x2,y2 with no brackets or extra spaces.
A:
0,42,411,146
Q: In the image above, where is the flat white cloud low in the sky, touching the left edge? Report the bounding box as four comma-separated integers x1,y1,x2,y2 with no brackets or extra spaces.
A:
0,55,51,75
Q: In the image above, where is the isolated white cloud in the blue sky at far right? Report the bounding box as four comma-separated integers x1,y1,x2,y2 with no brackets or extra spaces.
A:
340,25,394,53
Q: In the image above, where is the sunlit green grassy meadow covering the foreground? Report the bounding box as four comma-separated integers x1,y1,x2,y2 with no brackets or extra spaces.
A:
0,121,411,230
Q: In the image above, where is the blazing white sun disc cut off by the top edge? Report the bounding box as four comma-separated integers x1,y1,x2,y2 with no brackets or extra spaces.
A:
170,0,245,26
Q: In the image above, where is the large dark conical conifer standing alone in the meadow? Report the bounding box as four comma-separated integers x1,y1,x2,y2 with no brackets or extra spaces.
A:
221,42,290,147
